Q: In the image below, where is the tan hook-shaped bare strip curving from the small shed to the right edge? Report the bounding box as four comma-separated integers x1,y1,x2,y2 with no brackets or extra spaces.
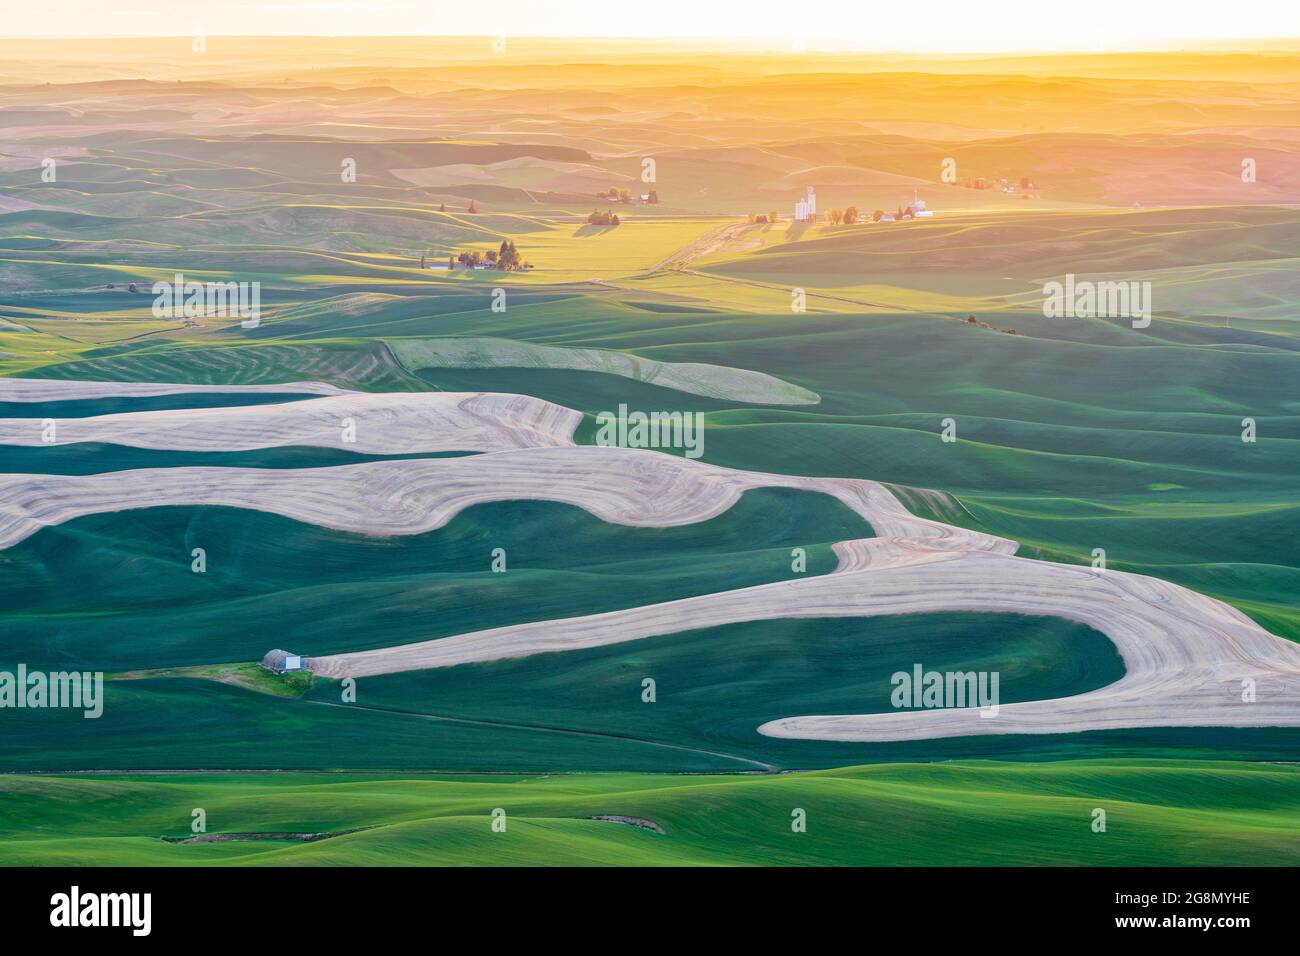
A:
311,538,1300,741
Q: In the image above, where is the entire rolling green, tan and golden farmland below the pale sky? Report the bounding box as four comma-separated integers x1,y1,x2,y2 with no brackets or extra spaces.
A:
0,38,1300,866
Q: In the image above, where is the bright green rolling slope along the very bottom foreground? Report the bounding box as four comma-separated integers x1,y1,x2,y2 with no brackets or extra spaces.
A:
0,761,1300,865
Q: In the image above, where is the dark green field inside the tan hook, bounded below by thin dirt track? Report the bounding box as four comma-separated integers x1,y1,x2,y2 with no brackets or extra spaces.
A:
308,614,1123,769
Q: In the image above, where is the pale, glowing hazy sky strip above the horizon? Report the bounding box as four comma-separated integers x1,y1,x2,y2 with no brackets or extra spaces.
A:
0,0,1300,51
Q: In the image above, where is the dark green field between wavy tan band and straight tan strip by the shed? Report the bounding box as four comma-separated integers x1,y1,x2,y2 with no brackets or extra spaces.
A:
0,486,871,670
